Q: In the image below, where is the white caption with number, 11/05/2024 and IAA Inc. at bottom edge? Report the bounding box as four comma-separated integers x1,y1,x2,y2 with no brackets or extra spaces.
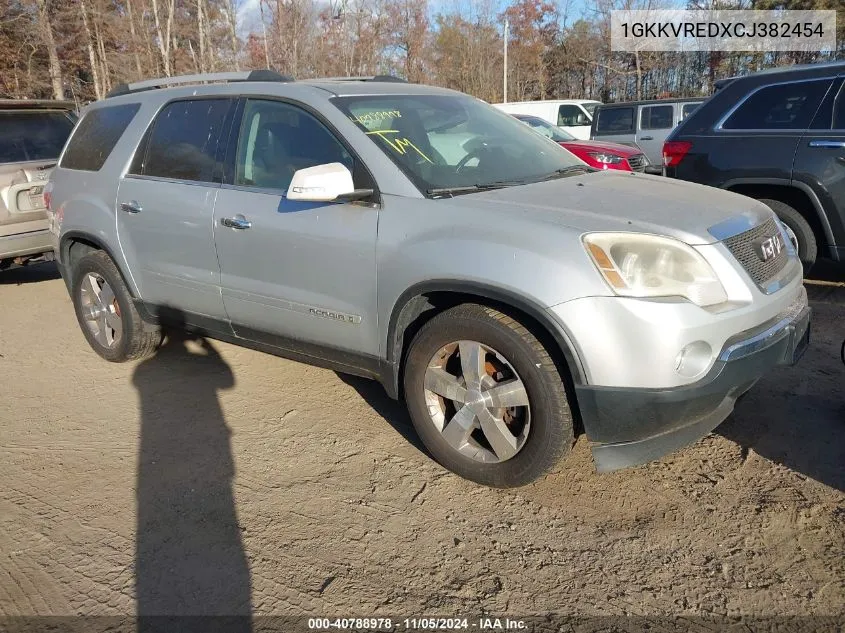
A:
308,617,528,631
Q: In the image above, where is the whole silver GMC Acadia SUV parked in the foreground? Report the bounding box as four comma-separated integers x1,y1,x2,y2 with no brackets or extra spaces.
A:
50,71,810,486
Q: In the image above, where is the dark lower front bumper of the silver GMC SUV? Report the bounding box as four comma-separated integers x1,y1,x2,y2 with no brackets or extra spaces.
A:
575,295,810,472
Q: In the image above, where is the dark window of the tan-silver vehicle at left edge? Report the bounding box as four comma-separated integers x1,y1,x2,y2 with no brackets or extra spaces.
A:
0,110,73,163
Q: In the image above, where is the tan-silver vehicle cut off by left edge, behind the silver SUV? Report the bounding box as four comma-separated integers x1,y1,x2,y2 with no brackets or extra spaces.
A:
0,99,76,270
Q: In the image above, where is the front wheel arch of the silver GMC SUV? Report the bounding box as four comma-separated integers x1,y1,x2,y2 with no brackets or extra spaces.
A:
382,280,587,422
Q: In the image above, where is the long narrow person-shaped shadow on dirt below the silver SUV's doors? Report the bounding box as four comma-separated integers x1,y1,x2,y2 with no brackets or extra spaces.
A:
132,314,252,633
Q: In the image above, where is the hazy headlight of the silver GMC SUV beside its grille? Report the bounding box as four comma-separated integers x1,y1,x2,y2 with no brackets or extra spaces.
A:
584,233,728,306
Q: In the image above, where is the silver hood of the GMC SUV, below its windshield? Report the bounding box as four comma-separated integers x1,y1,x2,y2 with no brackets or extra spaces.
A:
453,170,772,244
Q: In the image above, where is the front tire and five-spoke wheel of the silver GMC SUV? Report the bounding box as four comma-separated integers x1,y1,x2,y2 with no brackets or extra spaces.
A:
404,304,574,488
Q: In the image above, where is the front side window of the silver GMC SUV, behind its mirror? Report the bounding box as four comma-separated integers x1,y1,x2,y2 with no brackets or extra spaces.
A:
235,100,354,191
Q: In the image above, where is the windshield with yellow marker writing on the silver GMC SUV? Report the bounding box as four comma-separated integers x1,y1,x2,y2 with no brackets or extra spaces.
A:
333,94,586,195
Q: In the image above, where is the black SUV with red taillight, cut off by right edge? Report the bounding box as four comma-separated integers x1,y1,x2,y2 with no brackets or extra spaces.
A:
663,62,845,271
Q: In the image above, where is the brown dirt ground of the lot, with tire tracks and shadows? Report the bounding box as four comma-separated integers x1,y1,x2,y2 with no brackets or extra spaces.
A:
0,266,845,629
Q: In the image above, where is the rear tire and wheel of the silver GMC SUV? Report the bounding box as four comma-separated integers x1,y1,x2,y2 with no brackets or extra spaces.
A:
71,251,161,363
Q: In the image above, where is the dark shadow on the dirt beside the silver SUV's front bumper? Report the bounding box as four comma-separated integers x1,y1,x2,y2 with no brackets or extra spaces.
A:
716,288,845,491
